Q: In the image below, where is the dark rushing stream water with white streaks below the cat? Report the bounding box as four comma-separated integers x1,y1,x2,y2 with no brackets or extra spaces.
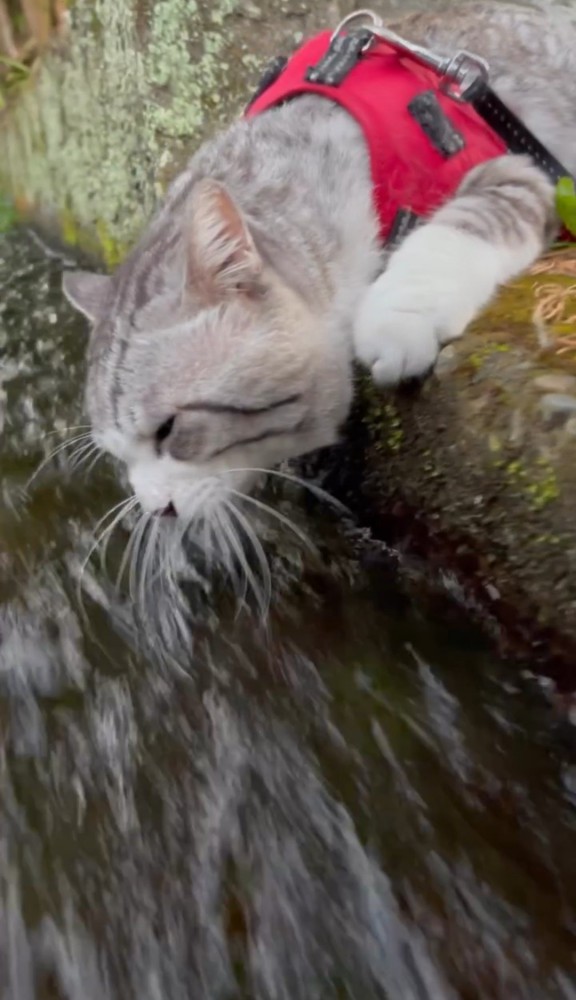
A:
0,234,576,1000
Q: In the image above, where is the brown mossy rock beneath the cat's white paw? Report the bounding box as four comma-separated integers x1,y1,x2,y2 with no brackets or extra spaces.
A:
332,254,576,688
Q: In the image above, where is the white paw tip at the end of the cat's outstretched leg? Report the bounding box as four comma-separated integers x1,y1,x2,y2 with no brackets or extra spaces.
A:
354,286,440,386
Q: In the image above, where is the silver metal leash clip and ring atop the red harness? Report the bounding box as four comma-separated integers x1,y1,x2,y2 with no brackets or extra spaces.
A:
331,9,490,102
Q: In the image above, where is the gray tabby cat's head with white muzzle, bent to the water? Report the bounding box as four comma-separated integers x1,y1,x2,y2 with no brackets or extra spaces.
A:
64,180,351,520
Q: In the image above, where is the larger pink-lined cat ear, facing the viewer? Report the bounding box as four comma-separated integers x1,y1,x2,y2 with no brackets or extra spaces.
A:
186,178,262,303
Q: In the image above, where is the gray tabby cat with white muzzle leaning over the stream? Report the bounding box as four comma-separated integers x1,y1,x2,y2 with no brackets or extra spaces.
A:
65,4,576,521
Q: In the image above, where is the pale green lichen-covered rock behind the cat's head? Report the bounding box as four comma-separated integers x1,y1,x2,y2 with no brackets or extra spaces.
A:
0,0,333,266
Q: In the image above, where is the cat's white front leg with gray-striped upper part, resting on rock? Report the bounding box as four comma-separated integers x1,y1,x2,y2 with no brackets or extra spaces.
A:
354,156,557,385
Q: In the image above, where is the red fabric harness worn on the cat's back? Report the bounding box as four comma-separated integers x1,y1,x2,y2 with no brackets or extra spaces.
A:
245,32,507,240
